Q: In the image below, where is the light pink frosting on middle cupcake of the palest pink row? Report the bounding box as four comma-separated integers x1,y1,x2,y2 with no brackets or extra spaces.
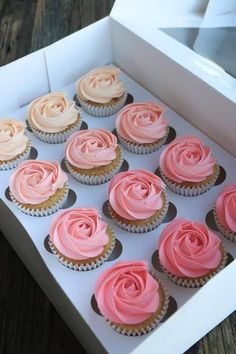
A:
66,129,117,169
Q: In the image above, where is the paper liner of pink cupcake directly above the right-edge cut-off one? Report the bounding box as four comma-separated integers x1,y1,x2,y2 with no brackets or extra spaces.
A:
160,168,219,197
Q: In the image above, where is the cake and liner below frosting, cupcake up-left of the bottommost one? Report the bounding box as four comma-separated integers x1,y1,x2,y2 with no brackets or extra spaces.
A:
49,226,115,271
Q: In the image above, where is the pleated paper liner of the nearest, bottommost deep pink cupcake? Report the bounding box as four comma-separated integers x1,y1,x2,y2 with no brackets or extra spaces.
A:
106,273,169,336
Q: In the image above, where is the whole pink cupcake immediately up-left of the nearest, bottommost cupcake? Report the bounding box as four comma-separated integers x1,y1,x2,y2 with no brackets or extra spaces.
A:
49,208,115,270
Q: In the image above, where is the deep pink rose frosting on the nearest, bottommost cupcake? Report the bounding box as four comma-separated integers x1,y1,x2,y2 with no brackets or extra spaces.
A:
95,261,160,324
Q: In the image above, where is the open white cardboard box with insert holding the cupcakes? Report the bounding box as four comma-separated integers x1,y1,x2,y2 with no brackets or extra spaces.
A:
0,0,236,354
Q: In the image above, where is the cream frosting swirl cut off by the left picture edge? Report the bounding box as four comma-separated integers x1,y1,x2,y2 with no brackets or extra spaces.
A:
0,118,29,161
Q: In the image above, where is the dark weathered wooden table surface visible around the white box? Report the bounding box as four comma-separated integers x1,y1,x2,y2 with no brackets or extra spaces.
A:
0,0,236,354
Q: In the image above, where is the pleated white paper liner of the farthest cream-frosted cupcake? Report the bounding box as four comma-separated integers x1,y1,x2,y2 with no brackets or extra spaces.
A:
76,92,127,118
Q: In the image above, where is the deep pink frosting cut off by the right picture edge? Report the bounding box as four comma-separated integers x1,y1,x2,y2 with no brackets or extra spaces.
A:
215,183,236,233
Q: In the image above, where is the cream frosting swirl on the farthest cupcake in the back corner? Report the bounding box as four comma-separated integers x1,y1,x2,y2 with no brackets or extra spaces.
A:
76,66,125,104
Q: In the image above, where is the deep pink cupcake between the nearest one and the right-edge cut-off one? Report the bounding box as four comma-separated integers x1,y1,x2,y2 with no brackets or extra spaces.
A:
158,218,226,288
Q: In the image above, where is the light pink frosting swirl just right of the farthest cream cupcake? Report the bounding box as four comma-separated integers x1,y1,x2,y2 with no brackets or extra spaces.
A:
116,102,168,144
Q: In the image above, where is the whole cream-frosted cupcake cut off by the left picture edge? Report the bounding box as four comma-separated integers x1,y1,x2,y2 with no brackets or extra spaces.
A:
0,118,31,171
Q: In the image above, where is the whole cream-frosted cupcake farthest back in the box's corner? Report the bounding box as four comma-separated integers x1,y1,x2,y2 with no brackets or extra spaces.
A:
76,66,127,117
